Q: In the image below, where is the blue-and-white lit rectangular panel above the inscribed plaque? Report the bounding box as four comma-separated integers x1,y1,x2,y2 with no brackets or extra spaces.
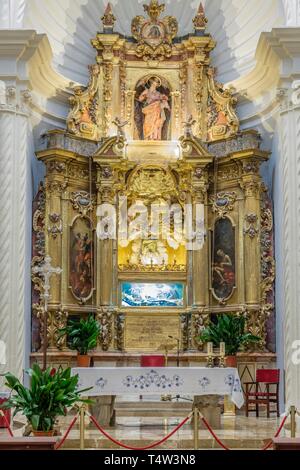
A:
122,282,184,307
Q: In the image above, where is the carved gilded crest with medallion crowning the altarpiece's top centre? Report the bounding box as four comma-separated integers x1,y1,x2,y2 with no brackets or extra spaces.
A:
131,0,178,61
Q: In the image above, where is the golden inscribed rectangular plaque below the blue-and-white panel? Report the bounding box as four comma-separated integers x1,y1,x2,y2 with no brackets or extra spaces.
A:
125,315,180,352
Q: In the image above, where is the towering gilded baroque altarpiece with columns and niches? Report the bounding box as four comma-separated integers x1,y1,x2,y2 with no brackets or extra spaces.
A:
32,0,275,364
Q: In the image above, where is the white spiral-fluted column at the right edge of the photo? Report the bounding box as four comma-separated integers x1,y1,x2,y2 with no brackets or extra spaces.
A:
277,82,300,410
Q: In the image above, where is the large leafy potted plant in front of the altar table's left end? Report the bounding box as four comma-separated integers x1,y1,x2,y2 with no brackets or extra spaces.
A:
2,364,90,437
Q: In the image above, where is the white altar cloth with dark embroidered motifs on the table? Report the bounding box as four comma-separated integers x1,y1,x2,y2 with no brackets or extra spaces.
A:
72,367,244,408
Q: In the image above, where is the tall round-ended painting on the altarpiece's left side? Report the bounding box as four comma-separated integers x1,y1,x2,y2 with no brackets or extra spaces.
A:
70,218,93,300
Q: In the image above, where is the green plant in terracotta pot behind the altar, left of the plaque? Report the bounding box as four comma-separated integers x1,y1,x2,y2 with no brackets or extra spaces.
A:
60,315,100,367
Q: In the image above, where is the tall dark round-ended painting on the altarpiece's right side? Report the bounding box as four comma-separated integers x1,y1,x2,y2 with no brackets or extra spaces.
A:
212,218,236,300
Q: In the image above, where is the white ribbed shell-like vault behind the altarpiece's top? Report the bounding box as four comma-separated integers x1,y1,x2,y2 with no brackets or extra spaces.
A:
24,0,284,84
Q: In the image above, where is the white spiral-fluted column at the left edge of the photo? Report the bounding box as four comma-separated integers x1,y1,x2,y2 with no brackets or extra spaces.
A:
0,81,31,386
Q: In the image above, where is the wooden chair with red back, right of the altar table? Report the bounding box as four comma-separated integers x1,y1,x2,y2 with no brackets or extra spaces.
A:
245,369,280,418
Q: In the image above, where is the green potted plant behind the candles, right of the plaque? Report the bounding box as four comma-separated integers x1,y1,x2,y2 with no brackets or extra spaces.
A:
199,314,261,367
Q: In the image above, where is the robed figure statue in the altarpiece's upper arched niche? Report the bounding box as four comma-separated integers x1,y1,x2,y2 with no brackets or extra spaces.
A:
136,77,171,140
